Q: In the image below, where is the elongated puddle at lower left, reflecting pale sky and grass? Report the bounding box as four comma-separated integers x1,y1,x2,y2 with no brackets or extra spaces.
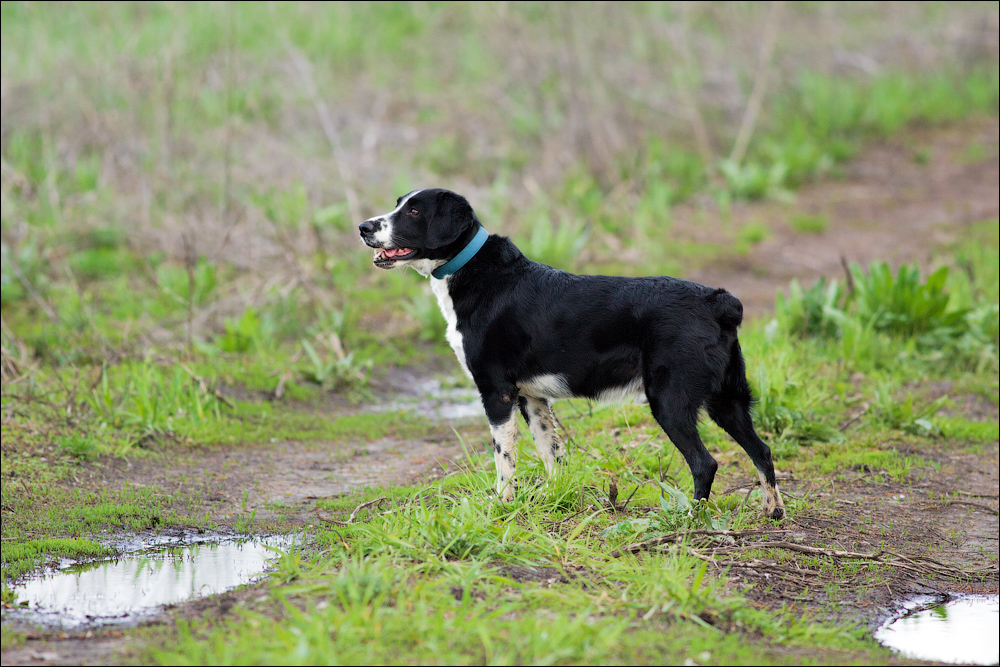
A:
5,535,292,629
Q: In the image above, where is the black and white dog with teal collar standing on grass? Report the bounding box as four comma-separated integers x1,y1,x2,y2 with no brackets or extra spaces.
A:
360,189,785,519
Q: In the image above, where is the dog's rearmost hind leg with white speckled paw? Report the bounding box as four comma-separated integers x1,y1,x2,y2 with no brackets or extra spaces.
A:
706,343,785,519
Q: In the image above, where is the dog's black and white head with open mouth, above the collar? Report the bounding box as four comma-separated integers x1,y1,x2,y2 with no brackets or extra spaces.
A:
358,189,479,274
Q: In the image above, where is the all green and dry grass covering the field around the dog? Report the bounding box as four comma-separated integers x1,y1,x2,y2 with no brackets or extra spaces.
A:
0,3,1000,664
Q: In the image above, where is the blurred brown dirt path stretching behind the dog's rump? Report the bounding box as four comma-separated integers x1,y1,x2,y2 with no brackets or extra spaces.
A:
675,119,1000,316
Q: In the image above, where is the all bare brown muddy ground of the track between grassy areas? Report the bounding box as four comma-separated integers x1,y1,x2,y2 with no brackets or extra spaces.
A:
3,121,1000,665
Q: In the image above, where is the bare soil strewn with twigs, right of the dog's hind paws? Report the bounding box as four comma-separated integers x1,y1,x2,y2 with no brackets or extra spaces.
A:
704,443,1000,627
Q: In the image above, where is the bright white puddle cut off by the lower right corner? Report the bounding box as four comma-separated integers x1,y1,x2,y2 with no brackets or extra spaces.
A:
875,595,1000,665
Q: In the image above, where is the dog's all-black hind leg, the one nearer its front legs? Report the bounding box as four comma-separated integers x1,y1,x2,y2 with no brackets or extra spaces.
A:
646,372,719,500
